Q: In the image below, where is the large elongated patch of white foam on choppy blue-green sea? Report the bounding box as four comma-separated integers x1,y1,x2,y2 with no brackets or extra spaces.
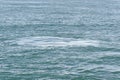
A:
16,36,99,47
